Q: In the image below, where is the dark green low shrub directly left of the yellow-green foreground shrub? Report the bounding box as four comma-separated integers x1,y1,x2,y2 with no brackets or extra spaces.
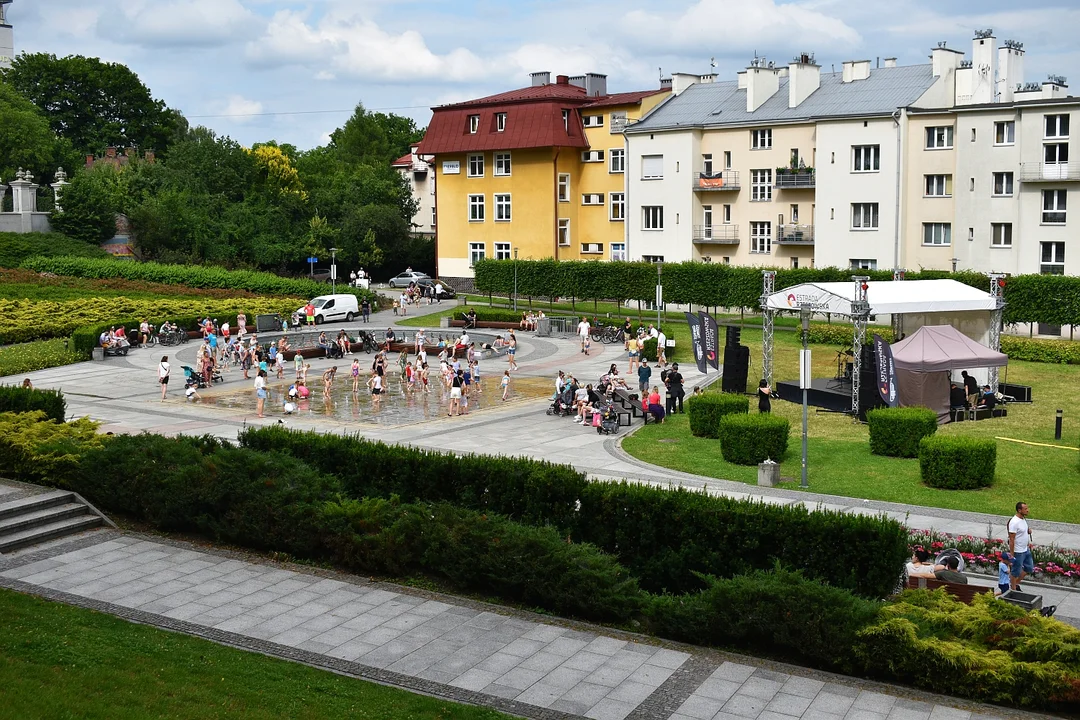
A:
646,568,880,673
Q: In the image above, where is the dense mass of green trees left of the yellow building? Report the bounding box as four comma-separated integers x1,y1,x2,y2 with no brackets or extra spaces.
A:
0,54,434,276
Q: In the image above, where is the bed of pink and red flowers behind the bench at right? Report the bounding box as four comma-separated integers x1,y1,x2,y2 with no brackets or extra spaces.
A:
908,528,1080,587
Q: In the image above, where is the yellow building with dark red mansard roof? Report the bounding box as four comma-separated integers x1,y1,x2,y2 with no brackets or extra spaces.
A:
419,72,669,289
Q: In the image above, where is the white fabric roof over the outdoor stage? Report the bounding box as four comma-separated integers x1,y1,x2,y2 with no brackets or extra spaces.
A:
767,280,996,315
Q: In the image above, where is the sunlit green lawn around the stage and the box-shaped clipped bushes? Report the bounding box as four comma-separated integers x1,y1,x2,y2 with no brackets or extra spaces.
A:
622,326,1080,522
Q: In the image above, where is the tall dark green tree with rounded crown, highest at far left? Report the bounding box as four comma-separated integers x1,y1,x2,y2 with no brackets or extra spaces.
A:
3,53,181,155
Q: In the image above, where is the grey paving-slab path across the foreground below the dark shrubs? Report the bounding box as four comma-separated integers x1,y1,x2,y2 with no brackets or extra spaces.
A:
0,530,1044,720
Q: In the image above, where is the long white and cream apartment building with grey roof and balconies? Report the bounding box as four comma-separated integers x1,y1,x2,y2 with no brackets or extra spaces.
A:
626,30,1080,274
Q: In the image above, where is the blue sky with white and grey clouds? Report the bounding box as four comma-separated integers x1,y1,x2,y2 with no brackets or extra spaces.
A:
8,0,1080,149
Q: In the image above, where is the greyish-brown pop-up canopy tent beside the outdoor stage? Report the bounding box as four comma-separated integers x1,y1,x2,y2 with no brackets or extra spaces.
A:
892,325,1009,422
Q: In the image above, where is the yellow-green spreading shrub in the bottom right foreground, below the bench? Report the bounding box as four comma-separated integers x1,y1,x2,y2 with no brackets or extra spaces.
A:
854,589,1080,710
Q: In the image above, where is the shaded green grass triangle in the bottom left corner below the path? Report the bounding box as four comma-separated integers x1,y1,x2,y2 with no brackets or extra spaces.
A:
0,590,508,720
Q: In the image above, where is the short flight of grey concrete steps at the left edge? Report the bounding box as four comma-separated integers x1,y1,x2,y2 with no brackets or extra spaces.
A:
0,490,112,553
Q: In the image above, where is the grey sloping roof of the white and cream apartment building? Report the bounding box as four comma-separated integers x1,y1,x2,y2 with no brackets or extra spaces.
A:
626,65,935,133
